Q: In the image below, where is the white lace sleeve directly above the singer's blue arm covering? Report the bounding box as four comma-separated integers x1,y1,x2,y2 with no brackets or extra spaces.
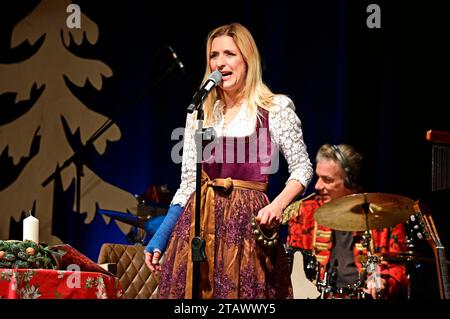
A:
171,114,196,207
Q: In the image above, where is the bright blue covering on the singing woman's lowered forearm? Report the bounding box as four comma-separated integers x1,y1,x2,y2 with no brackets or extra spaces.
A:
145,204,183,253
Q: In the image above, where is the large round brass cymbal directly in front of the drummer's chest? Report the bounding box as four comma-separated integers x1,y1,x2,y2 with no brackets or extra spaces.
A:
314,193,414,231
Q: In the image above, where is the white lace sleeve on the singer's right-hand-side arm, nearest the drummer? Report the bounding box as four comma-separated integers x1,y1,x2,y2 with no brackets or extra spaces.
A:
269,96,313,189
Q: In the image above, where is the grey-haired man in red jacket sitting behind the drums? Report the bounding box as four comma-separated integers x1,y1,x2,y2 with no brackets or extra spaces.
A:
285,144,408,298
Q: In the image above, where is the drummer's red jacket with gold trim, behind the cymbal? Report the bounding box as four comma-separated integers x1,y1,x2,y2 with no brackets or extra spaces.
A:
287,197,408,297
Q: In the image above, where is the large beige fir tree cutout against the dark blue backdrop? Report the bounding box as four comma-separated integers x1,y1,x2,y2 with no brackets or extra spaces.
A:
0,0,136,244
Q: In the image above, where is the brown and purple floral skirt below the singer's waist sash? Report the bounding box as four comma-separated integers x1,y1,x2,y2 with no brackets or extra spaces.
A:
158,188,292,299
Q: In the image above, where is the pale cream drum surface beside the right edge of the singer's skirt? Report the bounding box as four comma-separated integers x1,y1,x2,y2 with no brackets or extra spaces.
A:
291,250,320,299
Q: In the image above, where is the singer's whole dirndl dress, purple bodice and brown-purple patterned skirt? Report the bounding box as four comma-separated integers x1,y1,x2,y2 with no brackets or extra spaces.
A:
157,109,292,299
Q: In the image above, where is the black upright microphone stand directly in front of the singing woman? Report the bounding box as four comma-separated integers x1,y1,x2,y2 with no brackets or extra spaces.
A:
188,99,214,299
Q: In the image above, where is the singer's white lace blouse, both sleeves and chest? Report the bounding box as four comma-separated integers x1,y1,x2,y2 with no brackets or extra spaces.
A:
171,95,313,207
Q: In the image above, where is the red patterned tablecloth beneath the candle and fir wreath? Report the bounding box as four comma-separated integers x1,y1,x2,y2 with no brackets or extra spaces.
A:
0,269,123,299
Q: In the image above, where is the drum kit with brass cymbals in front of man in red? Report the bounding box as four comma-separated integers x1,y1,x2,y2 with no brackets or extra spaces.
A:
300,193,428,299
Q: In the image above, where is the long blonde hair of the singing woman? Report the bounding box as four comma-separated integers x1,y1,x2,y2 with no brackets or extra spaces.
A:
202,23,275,125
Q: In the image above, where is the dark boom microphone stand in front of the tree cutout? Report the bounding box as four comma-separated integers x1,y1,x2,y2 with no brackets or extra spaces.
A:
41,58,182,218
